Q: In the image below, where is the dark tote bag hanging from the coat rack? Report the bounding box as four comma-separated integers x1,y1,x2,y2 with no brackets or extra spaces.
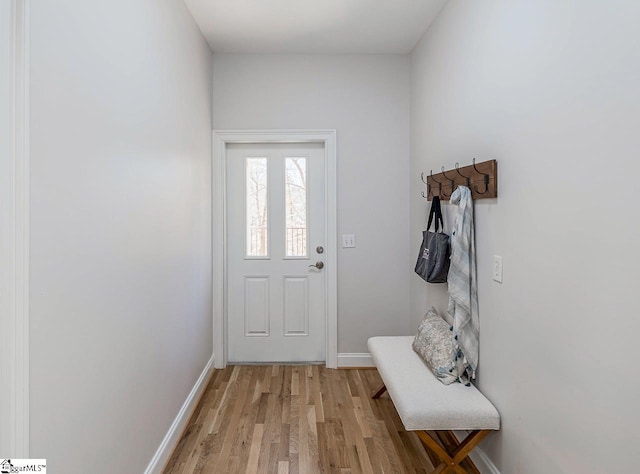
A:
415,196,451,283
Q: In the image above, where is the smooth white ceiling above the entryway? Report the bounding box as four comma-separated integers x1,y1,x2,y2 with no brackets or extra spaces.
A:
184,0,446,54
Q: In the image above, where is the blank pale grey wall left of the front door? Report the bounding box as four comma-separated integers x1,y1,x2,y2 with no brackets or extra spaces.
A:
30,0,212,473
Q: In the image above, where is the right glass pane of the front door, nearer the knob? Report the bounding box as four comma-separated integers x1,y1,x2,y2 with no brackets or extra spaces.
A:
284,158,307,257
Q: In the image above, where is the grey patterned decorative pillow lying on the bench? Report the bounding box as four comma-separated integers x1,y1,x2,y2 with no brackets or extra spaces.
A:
413,308,464,385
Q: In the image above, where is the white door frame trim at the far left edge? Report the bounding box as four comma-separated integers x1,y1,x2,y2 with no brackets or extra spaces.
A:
0,0,30,458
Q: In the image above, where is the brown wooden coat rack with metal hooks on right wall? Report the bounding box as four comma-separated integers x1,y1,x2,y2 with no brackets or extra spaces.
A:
421,158,498,201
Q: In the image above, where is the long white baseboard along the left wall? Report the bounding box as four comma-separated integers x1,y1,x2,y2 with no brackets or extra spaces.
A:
144,355,214,474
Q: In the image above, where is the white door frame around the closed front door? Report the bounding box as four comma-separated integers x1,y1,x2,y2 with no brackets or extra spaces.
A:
211,130,338,369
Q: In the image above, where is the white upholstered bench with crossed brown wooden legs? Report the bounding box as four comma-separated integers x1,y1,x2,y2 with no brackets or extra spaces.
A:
367,336,500,473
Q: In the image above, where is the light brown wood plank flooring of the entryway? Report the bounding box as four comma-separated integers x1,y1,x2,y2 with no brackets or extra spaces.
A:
164,365,433,474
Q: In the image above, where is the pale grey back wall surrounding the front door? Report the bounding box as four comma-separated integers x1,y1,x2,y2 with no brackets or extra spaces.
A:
213,53,412,353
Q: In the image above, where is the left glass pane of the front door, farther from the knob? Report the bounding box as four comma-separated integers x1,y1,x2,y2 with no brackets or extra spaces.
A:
245,158,269,257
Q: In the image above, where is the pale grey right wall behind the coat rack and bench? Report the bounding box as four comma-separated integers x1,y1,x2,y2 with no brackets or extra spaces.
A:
411,0,640,474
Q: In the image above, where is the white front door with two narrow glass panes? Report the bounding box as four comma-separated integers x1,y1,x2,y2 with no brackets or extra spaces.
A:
226,143,326,363
